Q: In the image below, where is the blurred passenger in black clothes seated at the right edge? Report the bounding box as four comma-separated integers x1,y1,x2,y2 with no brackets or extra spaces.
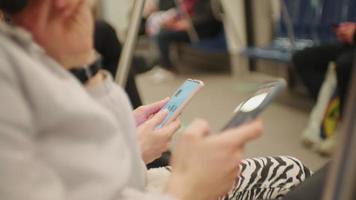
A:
293,22,356,111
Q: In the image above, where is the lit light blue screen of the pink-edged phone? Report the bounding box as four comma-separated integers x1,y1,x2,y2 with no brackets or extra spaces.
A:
158,80,201,128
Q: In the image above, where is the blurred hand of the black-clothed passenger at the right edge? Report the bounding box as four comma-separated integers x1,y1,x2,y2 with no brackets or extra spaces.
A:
336,22,356,44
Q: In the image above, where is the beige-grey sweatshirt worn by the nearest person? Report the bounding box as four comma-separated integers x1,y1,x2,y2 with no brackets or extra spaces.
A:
0,25,171,200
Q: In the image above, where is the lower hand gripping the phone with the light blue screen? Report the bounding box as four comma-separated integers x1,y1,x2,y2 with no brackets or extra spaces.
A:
138,110,180,164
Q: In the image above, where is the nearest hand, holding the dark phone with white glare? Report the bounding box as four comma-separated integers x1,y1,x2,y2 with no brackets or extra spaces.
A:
166,120,263,200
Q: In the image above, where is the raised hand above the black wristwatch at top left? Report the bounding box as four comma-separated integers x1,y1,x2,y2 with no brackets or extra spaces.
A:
48,0,96,68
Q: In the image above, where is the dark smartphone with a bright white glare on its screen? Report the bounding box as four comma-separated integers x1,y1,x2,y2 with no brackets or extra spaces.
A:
222,79,287,130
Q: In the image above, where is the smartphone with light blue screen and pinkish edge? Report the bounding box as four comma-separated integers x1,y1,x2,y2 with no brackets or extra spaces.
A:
157,79,204,128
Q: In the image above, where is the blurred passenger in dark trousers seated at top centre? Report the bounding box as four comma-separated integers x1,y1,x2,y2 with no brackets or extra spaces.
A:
147,0,223,76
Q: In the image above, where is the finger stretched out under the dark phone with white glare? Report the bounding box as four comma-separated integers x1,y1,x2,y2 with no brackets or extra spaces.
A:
219,120,263,148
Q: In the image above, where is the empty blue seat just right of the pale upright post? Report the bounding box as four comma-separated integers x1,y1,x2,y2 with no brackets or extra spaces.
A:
242,0,318,63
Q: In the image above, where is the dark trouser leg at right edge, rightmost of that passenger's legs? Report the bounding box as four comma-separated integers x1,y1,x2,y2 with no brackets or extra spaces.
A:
336,50,356,113
